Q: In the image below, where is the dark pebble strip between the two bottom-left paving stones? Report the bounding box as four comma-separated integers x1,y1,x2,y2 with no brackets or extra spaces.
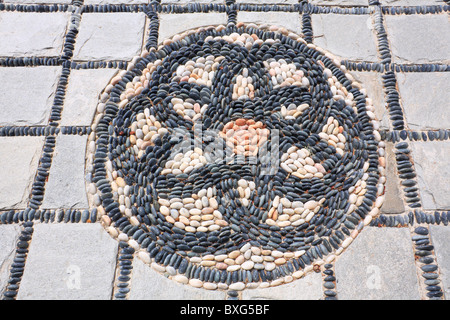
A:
3,222,33,300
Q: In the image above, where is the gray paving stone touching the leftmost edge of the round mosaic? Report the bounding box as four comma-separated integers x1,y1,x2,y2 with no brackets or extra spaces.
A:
42,135,89,209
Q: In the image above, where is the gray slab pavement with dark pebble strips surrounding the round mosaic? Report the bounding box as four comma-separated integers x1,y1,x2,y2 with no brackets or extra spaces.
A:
0,0,450,300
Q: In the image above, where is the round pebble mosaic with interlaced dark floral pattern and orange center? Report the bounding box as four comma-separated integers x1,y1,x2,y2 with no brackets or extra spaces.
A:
87,23,385,290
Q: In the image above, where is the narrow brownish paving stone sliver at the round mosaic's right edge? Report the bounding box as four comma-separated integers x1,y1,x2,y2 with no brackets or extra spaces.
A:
381,142,405,214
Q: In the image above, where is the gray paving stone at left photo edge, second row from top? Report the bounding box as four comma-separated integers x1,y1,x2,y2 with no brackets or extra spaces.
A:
0,67,61,126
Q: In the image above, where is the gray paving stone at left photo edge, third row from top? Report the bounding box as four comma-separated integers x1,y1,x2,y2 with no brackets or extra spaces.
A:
0,137,44,210
